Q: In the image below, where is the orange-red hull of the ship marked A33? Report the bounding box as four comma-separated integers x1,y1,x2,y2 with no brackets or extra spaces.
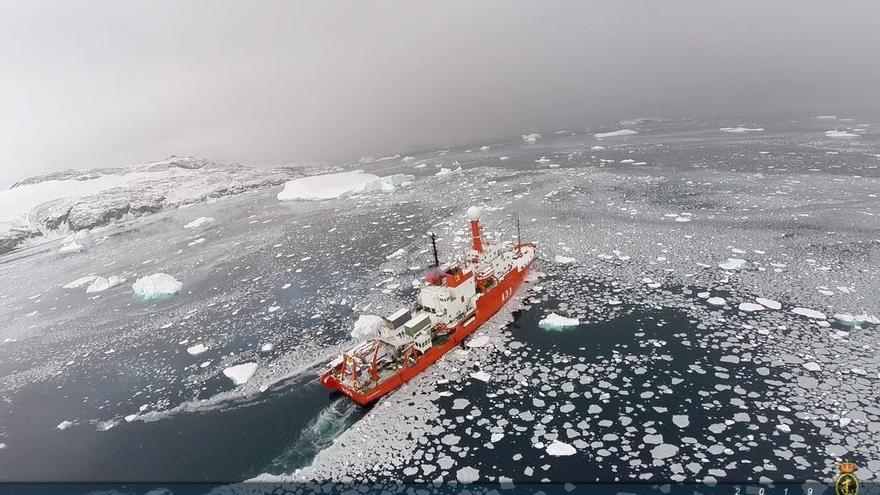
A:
321,243,535,406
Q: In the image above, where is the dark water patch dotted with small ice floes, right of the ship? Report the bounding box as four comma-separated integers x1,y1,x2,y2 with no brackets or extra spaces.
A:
440,299,824,483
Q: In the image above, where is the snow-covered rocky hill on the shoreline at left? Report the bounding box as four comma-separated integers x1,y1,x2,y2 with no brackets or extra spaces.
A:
0,156,328,254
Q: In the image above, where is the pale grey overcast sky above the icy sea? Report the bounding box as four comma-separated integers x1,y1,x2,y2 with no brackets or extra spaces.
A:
0,0,880,186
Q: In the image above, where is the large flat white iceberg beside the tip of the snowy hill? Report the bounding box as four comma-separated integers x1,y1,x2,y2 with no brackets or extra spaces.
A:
278,170,415,201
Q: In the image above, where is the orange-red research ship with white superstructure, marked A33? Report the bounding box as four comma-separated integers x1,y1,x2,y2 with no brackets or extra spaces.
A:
321,207,537,405
